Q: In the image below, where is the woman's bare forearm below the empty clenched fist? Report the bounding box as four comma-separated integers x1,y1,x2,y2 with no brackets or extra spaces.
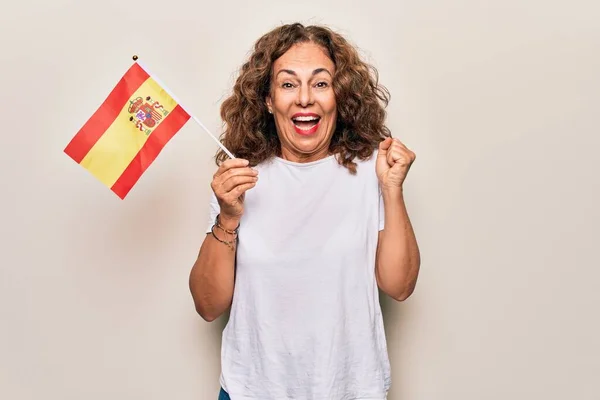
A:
376,188,421,301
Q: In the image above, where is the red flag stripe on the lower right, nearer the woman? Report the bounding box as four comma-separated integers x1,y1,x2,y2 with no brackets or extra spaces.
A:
111,105,190,199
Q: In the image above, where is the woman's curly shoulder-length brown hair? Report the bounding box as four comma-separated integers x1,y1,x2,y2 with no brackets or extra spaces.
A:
215,23,391,174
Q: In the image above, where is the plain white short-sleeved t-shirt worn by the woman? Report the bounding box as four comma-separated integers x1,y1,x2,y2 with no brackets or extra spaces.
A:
207,150,391,400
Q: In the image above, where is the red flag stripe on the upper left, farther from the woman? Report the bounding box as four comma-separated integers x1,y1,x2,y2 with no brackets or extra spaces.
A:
64,63,149,164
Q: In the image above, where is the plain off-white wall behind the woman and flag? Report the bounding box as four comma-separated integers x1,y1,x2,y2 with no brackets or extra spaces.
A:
0,0,600,400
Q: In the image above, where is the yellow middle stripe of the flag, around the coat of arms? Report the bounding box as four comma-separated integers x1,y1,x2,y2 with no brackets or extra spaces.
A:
80,77,177,187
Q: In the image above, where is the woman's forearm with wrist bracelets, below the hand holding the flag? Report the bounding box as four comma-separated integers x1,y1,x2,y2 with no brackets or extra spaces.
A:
189,216,236,321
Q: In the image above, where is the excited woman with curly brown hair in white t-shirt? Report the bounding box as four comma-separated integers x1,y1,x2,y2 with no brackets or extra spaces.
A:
190,24,420,400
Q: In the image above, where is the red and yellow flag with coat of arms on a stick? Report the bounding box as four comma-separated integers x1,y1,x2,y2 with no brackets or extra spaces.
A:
64,63,190,199
